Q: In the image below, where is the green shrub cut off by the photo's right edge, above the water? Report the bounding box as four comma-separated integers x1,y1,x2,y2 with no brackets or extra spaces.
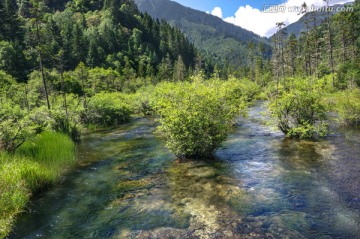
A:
335,88,360,125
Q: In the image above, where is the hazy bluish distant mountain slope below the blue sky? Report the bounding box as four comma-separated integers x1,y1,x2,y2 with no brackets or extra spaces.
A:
135,0,271,66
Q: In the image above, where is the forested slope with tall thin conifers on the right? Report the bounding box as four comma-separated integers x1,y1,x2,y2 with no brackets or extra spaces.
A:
272,1,360,84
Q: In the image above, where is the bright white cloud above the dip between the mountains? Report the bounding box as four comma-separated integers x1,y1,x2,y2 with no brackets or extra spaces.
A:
222,0,351,37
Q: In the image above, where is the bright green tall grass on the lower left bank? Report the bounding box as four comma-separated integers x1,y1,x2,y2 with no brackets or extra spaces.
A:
0,132,75,238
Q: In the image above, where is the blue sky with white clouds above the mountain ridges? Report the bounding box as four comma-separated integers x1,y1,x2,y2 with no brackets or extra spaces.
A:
173,0,353,37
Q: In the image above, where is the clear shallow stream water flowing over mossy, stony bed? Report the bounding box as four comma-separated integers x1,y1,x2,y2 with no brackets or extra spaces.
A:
10,105,360,239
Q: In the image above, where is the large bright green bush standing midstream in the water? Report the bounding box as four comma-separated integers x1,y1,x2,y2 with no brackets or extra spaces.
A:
155,76,248,158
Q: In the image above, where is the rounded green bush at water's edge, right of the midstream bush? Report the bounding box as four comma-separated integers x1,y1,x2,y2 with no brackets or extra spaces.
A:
269,78,328,138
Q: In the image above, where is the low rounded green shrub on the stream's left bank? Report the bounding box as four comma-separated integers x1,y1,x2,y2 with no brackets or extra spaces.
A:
84,92,131,127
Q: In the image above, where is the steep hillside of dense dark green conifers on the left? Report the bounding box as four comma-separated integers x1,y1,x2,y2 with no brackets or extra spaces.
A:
0,0,196,81
